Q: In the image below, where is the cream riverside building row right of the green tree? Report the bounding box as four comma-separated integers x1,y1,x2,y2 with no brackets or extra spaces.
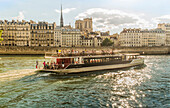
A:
119,28,168,47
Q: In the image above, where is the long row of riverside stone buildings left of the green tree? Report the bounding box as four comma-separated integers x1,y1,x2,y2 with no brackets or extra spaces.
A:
0,20,105,47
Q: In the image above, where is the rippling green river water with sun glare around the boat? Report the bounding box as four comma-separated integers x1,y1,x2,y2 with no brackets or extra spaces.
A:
0,56,170,108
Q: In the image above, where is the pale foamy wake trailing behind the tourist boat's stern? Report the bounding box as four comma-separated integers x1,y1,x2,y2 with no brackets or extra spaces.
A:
0,69,36,81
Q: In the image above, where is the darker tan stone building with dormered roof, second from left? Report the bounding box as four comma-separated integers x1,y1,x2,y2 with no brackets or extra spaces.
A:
30,22,56,46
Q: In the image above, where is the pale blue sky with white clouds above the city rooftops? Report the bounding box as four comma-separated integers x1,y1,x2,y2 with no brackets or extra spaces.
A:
0,0,170,34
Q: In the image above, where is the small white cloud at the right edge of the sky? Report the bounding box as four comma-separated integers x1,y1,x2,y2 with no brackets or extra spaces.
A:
152,15,170,24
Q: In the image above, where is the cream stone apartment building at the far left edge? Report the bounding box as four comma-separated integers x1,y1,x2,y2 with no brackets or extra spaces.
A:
0,20,30,46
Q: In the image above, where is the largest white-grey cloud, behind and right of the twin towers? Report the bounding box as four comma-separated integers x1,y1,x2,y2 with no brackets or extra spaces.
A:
75,8,153,32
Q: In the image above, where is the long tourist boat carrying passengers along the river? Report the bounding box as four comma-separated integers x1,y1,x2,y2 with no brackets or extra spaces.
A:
36,53,144,75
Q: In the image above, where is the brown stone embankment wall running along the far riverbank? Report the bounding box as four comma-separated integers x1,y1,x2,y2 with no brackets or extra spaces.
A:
0,46,170,55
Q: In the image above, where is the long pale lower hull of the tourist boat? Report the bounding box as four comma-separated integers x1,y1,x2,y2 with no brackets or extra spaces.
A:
36,59,144,75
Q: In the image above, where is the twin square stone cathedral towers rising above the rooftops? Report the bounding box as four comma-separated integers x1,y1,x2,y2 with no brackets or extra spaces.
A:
75,18,93,33
